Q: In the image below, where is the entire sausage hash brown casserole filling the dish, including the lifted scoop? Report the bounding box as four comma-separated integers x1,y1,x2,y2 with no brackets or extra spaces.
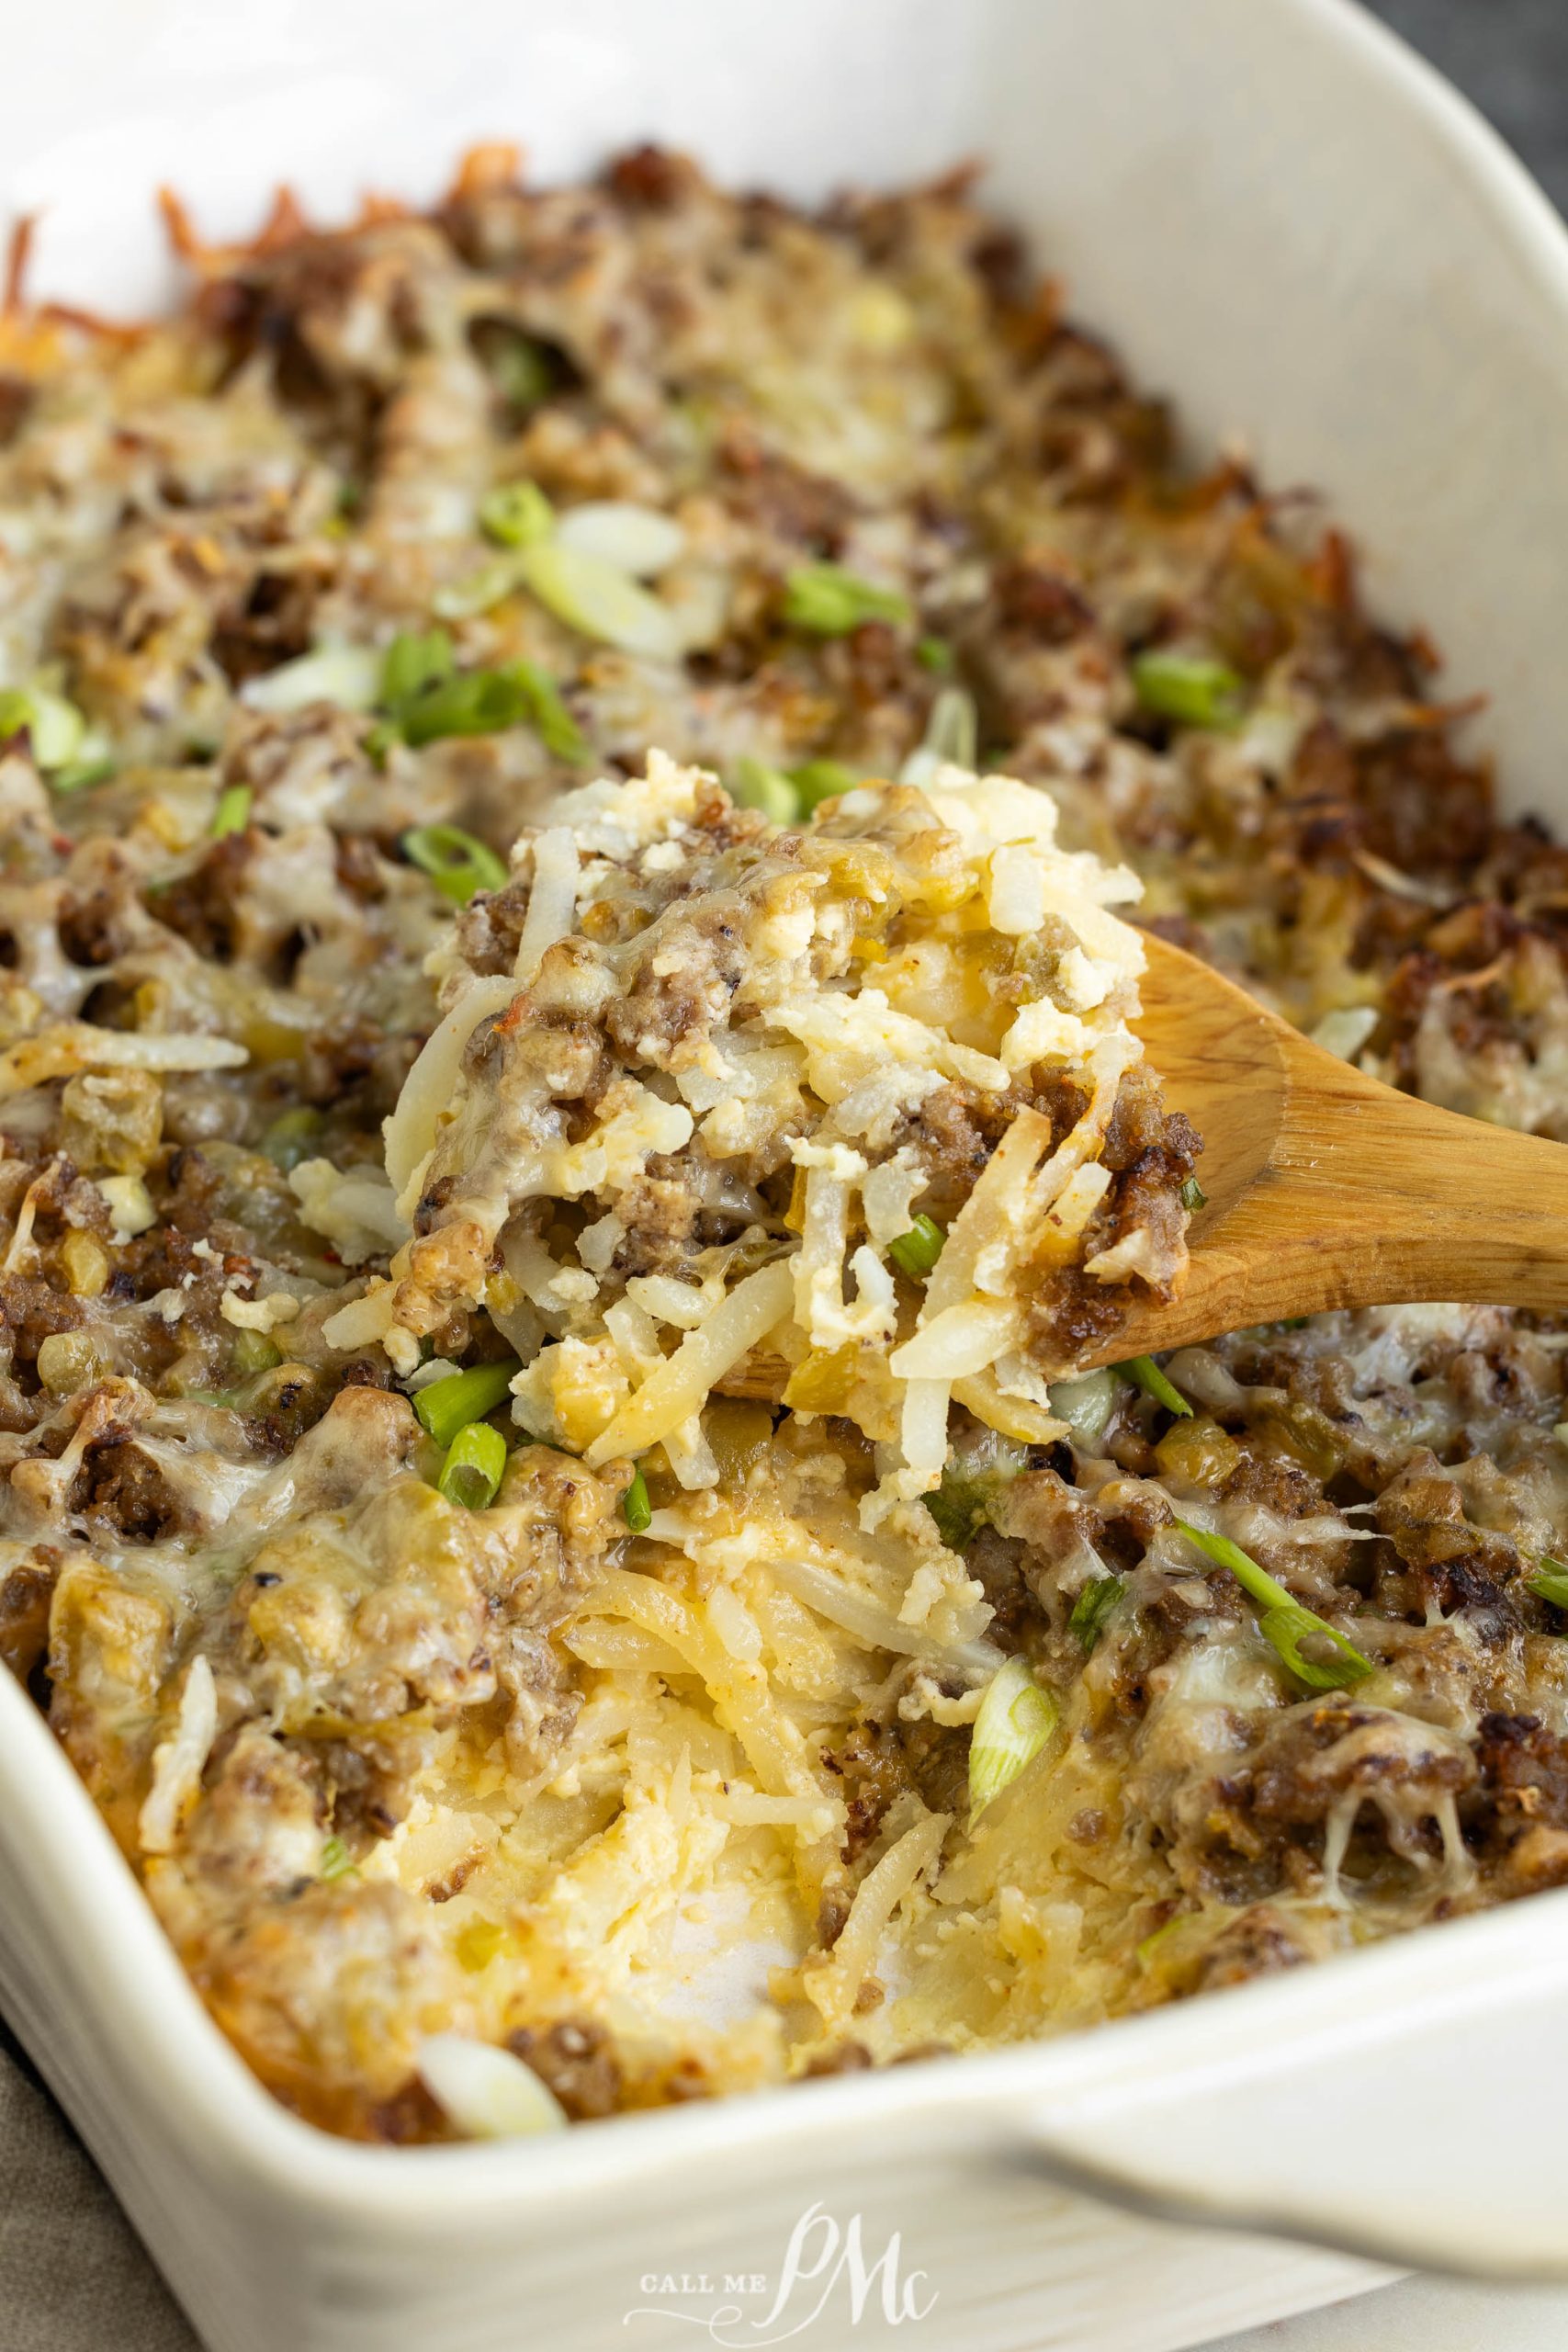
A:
0,151,1568,2141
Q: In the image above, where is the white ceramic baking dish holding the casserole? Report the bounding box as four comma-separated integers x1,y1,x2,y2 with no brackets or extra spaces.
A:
0,0,1568,2352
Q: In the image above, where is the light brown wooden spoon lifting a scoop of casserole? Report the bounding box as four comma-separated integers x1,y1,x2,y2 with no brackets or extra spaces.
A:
1081,933,1568,1369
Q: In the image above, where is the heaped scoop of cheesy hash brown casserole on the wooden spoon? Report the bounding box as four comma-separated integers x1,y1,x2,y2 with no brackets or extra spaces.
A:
362,752,1194,1515
